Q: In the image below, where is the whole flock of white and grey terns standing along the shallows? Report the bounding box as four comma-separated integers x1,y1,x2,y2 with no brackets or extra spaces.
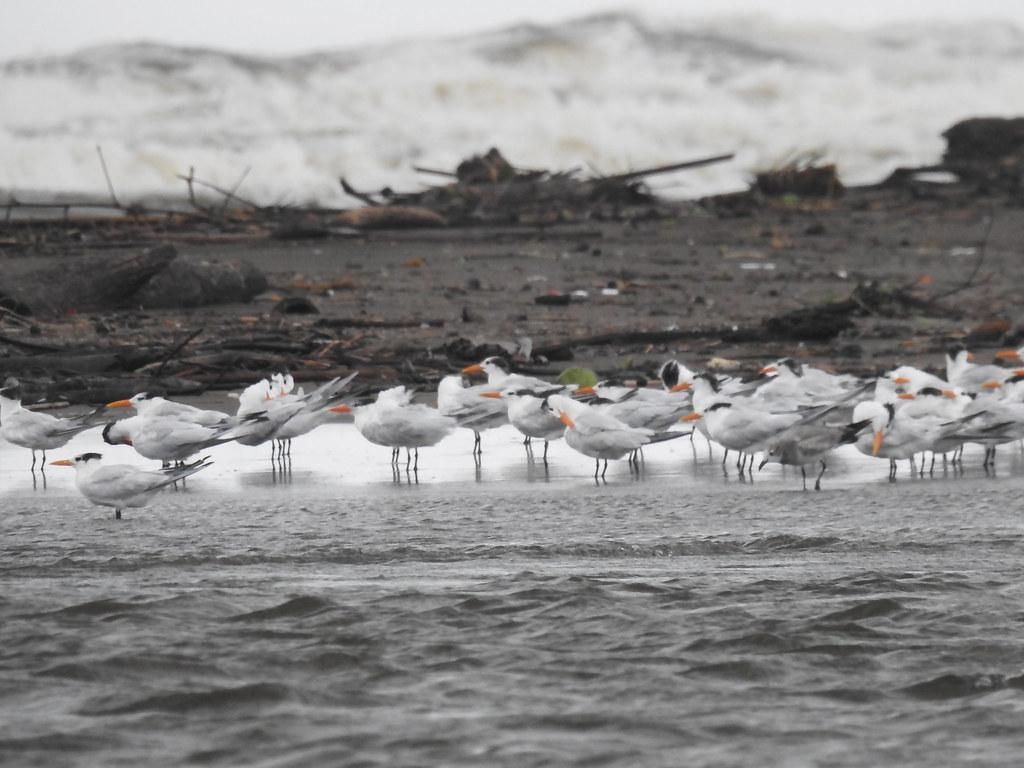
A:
0,347,1024,519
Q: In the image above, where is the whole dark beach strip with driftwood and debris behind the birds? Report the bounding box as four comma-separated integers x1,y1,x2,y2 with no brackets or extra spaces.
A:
0,119,1024,403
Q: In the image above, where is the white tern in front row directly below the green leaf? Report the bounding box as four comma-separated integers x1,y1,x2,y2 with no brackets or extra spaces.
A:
548,394,688,479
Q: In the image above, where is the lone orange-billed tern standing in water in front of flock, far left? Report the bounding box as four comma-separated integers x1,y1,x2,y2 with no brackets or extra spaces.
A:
50,453,213,520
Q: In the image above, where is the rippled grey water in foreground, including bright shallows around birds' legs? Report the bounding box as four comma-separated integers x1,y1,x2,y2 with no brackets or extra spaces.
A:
0,425,1024,766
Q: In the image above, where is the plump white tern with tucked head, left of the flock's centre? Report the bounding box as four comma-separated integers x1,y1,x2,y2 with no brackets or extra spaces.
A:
353,385,459,470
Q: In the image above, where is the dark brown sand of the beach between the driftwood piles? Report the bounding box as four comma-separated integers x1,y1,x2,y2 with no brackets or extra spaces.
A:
0,185,1024,399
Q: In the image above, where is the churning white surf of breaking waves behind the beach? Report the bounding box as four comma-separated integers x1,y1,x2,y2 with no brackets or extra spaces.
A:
0,14,1024,205
